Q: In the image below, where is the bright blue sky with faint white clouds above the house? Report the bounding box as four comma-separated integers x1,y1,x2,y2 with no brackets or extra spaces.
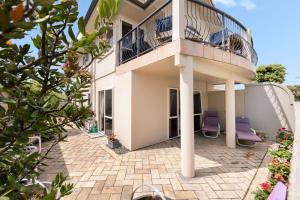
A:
18,0,300,85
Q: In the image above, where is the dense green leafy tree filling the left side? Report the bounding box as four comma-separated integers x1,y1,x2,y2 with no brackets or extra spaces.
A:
0,0,120,199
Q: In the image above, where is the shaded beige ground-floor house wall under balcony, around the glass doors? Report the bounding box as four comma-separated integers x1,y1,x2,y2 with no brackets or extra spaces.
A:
132,72,207,150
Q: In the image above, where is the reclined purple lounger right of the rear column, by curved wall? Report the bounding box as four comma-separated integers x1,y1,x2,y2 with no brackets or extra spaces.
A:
235,117,262,146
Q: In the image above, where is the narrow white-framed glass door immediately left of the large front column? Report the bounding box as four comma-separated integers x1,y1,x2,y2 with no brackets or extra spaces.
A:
169,89,179,138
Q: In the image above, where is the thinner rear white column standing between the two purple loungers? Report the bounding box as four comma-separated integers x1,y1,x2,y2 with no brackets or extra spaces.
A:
225,79,236,148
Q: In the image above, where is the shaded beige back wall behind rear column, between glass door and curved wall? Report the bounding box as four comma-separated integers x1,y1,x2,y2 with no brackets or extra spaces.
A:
207,90,245,131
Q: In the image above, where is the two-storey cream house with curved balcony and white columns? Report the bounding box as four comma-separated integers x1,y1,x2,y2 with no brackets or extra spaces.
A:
83,0,257,177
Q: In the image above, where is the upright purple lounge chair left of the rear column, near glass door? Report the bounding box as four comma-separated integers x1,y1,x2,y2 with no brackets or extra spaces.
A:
202,111,220,138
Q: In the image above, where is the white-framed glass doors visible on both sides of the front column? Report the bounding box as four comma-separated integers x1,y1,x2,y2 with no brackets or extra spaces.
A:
168,88,202,138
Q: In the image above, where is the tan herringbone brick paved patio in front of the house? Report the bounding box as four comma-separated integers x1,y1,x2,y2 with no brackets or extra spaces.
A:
40,130,268,200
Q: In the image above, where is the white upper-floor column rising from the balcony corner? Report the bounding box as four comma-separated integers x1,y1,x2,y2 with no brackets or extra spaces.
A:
172,0,186,41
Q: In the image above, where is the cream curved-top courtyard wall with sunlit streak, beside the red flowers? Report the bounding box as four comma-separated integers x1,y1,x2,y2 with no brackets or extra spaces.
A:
245,84,295,140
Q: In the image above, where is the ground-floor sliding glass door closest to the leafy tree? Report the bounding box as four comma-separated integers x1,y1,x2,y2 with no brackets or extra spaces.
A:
98,90,113,135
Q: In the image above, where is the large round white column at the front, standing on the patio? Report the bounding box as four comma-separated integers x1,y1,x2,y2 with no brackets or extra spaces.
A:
180,57,195,178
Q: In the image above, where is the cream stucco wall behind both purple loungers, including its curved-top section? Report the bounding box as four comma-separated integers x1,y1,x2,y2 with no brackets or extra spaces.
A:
208,84,295,140
